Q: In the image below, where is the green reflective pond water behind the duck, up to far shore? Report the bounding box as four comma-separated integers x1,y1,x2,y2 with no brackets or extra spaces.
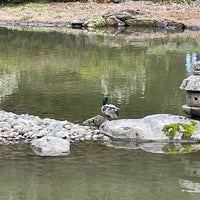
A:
0,28,199,122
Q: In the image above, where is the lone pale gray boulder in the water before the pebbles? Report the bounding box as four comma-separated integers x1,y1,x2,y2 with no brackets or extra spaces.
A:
31,136,70,156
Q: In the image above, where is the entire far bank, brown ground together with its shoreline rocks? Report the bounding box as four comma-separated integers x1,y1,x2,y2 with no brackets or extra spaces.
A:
0,1,200,31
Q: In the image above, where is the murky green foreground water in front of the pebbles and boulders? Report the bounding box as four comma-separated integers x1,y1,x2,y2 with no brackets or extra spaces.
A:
0,143,200,200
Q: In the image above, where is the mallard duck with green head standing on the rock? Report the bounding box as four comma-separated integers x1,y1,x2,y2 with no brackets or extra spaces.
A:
101,96,119,120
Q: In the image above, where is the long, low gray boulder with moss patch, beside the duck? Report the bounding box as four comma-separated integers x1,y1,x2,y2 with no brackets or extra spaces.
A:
100,114,200,142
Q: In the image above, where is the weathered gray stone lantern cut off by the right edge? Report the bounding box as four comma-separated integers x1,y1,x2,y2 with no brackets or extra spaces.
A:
180,61,200,118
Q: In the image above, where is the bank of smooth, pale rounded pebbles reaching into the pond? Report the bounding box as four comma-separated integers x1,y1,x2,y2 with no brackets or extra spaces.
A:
0,110,105,143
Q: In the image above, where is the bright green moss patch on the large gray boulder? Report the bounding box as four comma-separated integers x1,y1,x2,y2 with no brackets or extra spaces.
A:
162,121,197,139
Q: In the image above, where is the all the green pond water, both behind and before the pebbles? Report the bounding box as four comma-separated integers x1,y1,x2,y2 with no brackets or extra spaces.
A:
0,28,200,200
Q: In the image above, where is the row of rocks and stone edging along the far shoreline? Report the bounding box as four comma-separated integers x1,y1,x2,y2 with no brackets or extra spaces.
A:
0,15,196,31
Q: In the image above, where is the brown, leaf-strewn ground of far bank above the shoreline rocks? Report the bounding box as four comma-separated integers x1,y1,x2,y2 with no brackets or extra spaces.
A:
0,1,200,26
